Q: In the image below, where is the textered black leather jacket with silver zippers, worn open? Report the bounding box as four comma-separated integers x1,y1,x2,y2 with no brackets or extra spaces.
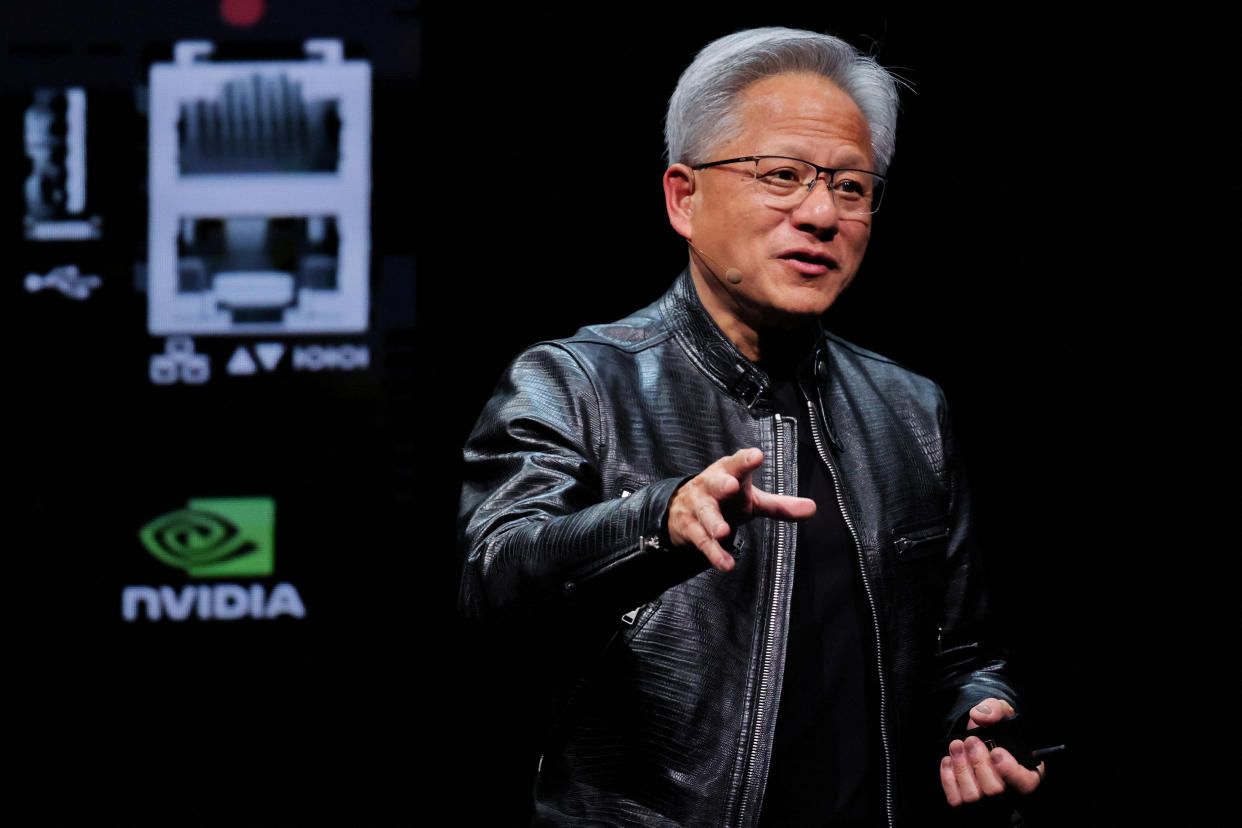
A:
460,272,1016,826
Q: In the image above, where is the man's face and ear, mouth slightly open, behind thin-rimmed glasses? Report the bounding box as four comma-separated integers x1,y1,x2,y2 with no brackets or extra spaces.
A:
666,73,876,336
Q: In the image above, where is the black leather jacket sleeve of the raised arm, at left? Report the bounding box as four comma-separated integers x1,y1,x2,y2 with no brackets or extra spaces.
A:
458,343,702,624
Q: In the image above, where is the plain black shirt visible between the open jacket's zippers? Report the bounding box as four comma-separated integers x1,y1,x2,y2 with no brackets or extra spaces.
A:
759,352,884,827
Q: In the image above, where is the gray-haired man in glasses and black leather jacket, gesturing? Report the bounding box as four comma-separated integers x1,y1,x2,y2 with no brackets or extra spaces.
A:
461,29,1042,826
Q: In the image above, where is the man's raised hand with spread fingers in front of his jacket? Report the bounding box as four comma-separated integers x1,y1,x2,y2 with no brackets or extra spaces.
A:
668,448,814,573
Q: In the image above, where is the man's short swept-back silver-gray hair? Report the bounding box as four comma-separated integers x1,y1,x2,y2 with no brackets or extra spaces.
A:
664,27,897,174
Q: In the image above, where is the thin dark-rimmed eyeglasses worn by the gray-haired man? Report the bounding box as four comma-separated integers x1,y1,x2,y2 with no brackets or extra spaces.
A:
691,155,884,215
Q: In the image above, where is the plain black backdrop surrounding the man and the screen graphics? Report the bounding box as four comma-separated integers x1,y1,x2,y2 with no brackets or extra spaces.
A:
7,0,1240,826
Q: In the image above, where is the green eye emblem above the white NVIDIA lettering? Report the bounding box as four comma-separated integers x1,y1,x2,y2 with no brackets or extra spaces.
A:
138,498,276,577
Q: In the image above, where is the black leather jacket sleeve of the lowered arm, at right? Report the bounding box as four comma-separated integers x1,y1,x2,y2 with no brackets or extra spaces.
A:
939,397,1021,741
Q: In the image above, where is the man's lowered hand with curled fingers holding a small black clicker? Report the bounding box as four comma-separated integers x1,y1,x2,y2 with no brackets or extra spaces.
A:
940,699,1043,808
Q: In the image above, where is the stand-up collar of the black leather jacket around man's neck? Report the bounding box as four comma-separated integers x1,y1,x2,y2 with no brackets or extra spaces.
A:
660,267,841,448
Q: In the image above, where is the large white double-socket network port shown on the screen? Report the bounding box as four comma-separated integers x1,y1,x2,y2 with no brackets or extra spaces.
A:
148,41,370,335
